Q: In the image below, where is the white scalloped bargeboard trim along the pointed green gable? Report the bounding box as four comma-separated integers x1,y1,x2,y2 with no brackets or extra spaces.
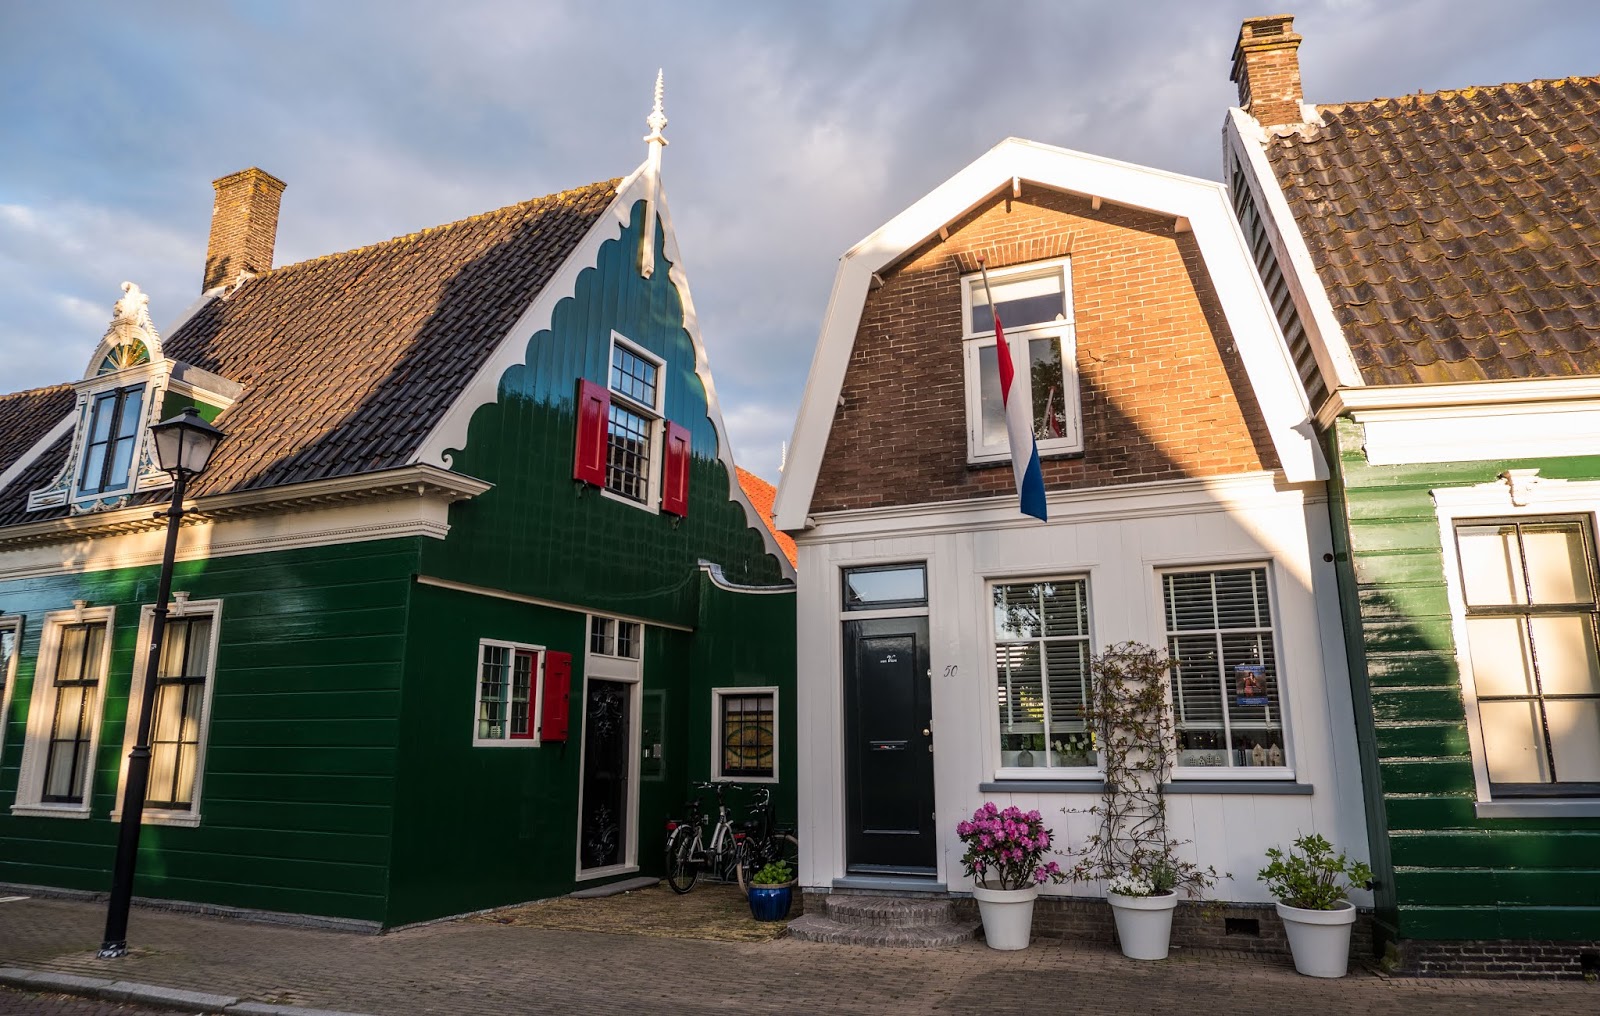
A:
411,162,795,581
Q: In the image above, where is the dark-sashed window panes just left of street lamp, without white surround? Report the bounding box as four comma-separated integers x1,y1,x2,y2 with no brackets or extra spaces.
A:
40,622,106,805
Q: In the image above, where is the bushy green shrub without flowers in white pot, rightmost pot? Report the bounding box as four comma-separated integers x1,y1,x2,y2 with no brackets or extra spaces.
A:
1256,834,1373,978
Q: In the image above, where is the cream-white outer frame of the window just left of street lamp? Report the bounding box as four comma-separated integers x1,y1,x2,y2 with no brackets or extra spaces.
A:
11,606,117,818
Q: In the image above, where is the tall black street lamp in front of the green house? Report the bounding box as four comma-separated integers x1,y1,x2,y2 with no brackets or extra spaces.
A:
99,406,224,960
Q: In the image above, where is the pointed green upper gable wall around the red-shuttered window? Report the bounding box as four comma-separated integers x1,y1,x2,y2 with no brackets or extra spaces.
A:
422,203,782,627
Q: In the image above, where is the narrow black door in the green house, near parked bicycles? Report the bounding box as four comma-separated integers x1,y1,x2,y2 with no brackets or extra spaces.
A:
578,680,632,870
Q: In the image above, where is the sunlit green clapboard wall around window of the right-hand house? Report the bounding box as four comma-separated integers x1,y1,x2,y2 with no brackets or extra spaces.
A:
1330,419,1600,939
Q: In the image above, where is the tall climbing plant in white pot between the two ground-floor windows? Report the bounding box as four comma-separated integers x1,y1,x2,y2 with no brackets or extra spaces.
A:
1072,642,1218,960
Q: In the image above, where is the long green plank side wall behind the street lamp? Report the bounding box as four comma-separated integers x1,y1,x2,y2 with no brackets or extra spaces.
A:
0,539,418,920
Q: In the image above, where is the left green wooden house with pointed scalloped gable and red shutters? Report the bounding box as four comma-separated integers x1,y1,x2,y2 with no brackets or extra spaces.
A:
0,95,795,926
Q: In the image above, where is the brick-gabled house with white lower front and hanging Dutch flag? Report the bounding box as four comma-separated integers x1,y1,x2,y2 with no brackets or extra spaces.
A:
776,132,1366,926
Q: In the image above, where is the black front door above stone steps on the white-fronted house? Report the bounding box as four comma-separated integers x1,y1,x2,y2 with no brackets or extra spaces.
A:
845,618,938,875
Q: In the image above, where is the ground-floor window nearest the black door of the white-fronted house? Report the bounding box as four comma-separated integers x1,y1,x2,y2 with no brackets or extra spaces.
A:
994,579,1098,768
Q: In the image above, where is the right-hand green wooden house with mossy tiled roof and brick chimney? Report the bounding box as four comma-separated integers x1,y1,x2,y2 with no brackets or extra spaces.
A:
1226,16,1600,976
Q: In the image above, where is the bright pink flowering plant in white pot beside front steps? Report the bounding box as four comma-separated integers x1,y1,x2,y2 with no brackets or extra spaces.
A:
955,802,1066,949
